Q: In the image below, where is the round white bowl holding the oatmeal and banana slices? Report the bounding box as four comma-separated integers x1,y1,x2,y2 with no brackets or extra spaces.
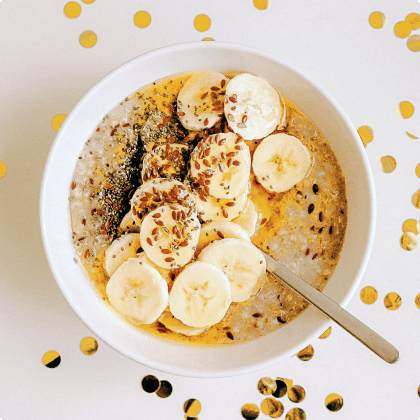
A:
41,42,375,377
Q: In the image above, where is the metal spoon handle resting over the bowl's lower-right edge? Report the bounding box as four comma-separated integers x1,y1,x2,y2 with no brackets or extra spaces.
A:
261,251,399,363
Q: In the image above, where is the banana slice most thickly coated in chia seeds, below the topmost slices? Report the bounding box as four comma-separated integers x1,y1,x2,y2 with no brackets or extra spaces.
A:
140,109,187,152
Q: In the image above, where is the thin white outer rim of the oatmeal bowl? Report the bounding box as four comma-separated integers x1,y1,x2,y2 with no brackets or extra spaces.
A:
40,41,376,377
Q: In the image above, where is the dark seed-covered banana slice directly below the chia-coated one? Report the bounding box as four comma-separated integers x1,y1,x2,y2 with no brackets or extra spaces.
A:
141,143,190,182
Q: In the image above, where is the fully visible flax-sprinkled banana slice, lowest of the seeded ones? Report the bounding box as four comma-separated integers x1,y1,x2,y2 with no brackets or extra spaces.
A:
140,204,200,269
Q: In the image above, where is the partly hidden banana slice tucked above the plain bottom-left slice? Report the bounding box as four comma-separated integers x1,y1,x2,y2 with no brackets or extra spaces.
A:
104,233,140,277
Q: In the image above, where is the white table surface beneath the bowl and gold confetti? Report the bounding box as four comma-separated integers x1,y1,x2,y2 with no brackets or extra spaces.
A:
0,0,420,420
